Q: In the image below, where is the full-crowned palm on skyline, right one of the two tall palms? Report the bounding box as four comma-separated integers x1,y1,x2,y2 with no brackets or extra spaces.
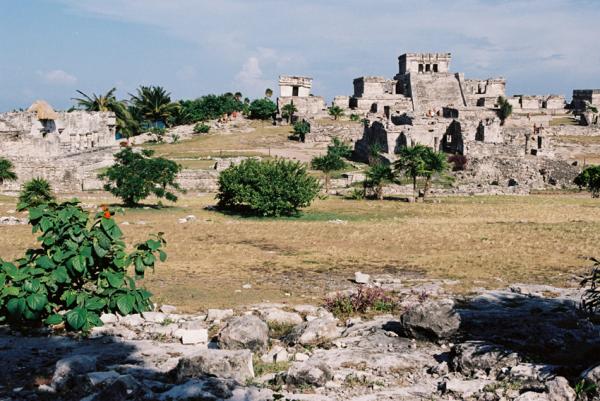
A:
129,85,179,125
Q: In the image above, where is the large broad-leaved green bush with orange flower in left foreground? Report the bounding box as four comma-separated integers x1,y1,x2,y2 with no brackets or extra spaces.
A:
0,200,167,330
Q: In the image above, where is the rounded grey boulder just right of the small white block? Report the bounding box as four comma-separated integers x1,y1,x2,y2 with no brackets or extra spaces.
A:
219,315,269,352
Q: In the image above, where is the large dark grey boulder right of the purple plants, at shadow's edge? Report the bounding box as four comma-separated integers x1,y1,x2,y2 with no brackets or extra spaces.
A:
400,300,460,340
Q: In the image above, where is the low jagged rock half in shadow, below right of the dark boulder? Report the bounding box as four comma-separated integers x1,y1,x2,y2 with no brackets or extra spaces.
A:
451,341,520,376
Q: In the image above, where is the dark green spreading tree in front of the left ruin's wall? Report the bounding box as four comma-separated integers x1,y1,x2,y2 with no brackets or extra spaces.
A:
98,147,183,206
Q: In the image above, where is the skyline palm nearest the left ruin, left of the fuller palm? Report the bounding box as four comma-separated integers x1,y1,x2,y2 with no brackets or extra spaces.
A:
73,88,138,138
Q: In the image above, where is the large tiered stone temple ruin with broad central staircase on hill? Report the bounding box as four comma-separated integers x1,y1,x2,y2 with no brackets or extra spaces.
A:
334,53,578,191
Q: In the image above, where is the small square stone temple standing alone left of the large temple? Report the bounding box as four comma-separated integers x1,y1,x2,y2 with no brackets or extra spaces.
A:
277,75,327,118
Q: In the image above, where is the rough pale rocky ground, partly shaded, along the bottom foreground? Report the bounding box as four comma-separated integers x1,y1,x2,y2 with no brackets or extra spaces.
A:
0,277,600,401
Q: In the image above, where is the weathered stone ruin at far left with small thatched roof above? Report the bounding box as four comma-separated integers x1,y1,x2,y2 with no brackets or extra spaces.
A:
0,101,118,191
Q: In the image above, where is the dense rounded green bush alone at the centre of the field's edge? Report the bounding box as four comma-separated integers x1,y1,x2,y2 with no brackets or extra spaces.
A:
217,159,319,216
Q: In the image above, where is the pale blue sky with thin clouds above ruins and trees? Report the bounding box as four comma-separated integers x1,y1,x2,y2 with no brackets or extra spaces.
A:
0,0,600,111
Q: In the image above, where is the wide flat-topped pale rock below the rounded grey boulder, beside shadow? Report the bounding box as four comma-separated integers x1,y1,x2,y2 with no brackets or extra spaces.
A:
174,349,254,383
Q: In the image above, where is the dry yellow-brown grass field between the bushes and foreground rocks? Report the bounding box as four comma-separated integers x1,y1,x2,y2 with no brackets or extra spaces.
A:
0,194,600,311
